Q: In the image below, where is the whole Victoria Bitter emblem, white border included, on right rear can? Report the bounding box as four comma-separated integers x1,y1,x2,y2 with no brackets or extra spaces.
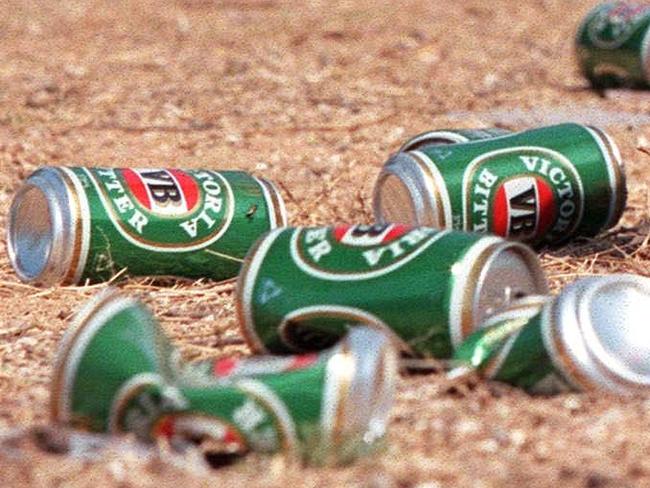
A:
463,147,584,241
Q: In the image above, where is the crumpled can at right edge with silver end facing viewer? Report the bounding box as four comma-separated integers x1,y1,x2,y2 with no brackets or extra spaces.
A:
451,274,650,394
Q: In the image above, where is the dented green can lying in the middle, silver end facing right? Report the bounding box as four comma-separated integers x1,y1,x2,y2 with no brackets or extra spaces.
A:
237,224,547,358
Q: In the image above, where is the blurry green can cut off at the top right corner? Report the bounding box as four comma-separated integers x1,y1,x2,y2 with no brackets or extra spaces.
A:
576,2,650,88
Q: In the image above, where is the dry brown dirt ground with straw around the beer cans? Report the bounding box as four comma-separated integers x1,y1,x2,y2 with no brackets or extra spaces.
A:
0,0,650,488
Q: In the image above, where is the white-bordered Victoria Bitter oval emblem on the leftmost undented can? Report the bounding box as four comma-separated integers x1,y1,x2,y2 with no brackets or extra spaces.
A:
91,168,234,252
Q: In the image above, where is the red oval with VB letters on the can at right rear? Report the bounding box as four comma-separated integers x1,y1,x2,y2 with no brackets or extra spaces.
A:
493,176,556,240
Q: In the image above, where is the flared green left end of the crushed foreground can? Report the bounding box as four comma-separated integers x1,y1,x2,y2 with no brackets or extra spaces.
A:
50,288,174,432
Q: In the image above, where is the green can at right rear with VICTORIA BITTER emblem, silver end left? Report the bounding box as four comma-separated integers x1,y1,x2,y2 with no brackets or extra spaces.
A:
373,124,626,244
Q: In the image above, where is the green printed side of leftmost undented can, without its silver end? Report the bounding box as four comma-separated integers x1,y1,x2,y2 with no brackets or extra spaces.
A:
58,168,286,282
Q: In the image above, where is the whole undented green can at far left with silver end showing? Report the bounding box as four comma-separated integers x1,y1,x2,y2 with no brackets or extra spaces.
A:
7,167,286,285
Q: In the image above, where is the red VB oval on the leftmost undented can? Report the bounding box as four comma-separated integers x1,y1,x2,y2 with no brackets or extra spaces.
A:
122,169,199,216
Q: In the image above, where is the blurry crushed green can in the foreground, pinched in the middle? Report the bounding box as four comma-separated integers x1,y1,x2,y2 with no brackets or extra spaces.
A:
51,291,397,461
